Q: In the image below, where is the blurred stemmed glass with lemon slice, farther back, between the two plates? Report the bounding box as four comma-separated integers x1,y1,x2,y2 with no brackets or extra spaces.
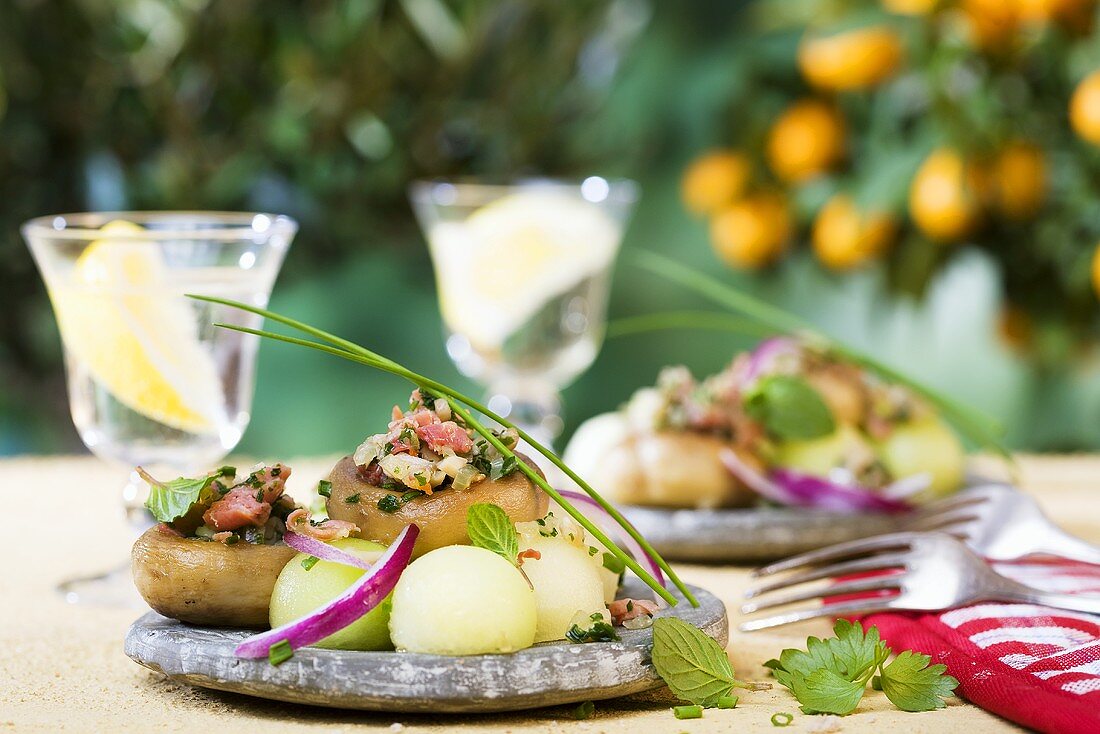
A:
409,176,638,446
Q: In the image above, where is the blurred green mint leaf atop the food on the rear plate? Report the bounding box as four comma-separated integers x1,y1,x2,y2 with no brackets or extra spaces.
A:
744,374,836,440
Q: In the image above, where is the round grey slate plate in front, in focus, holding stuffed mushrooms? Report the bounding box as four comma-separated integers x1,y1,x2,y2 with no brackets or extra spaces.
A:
125,580,729,713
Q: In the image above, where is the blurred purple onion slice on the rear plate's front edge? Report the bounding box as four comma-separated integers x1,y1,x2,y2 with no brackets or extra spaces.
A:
722,449,913,513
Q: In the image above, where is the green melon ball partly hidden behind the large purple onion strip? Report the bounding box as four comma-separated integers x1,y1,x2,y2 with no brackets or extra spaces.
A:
268,538,393,650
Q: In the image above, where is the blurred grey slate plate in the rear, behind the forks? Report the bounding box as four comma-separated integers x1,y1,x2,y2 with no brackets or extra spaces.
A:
619,506,898,562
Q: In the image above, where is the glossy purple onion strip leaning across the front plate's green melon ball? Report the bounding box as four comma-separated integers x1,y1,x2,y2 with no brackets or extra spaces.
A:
235,525,420,658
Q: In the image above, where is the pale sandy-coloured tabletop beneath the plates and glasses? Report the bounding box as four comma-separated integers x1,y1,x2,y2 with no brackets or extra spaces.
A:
0,457,1100,734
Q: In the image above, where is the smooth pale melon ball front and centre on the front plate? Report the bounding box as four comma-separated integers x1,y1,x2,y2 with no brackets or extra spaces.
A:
389,546,536,655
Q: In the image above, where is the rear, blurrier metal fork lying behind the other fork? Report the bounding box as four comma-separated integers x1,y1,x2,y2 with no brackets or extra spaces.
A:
900,483,1100,563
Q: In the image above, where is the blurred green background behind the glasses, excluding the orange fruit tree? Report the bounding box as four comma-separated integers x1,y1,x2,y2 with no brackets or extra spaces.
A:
0,0,1100,457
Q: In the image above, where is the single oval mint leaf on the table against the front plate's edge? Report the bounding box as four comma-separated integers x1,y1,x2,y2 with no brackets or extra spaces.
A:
651,617,739,706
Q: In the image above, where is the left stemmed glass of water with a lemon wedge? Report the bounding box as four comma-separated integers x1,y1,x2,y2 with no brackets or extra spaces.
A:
22,211,298,605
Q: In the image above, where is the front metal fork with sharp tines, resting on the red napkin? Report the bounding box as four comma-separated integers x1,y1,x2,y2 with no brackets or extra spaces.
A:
739,533,1100,632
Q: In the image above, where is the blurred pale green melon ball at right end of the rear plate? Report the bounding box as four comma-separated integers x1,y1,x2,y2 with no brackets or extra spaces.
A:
878,418,966,502
